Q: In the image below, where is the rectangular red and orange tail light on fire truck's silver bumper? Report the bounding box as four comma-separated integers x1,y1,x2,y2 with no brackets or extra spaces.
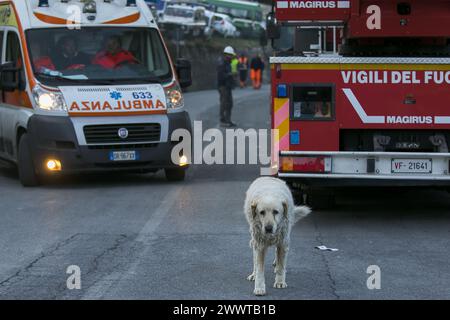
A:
281,157,331,173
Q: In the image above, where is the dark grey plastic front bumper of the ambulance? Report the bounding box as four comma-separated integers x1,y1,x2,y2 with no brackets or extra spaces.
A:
28,111,191,174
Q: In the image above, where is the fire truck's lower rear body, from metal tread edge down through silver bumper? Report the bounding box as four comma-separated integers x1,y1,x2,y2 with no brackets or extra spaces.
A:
270,56,450,186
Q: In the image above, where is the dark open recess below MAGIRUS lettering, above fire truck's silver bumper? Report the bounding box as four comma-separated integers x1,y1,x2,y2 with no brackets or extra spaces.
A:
339,129,450,152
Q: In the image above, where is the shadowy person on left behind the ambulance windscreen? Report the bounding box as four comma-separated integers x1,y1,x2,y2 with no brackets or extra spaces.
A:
54,36,91,70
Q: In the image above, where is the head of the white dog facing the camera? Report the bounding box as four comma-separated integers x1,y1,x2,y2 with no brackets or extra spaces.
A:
251,197,288,235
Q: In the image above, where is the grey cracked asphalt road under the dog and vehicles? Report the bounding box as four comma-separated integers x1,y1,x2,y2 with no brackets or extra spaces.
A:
0,87,450,299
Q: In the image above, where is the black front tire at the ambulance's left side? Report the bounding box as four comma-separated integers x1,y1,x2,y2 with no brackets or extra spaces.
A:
17,133,40,187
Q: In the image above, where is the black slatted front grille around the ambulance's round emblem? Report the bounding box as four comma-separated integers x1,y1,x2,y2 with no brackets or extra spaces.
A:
83,123,161,144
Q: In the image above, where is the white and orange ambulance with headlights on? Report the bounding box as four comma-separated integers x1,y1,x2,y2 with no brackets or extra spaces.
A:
0,0,191,186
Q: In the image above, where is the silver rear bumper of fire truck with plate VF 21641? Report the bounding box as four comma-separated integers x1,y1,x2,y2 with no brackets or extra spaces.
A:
278,151,450,186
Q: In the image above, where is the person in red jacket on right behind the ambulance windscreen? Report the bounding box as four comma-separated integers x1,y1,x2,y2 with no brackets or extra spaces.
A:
92,35,139,69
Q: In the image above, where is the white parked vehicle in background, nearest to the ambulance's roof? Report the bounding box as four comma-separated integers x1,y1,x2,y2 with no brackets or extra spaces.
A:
158,4,206,37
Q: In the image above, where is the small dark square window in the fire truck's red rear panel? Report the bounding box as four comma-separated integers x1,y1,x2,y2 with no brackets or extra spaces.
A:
291,85,334,120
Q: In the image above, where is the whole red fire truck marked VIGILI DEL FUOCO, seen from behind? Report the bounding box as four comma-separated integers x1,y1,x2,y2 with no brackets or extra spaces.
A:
267,0,450,208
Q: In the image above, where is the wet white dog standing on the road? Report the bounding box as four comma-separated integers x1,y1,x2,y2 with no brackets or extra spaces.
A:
244,177,311,296
